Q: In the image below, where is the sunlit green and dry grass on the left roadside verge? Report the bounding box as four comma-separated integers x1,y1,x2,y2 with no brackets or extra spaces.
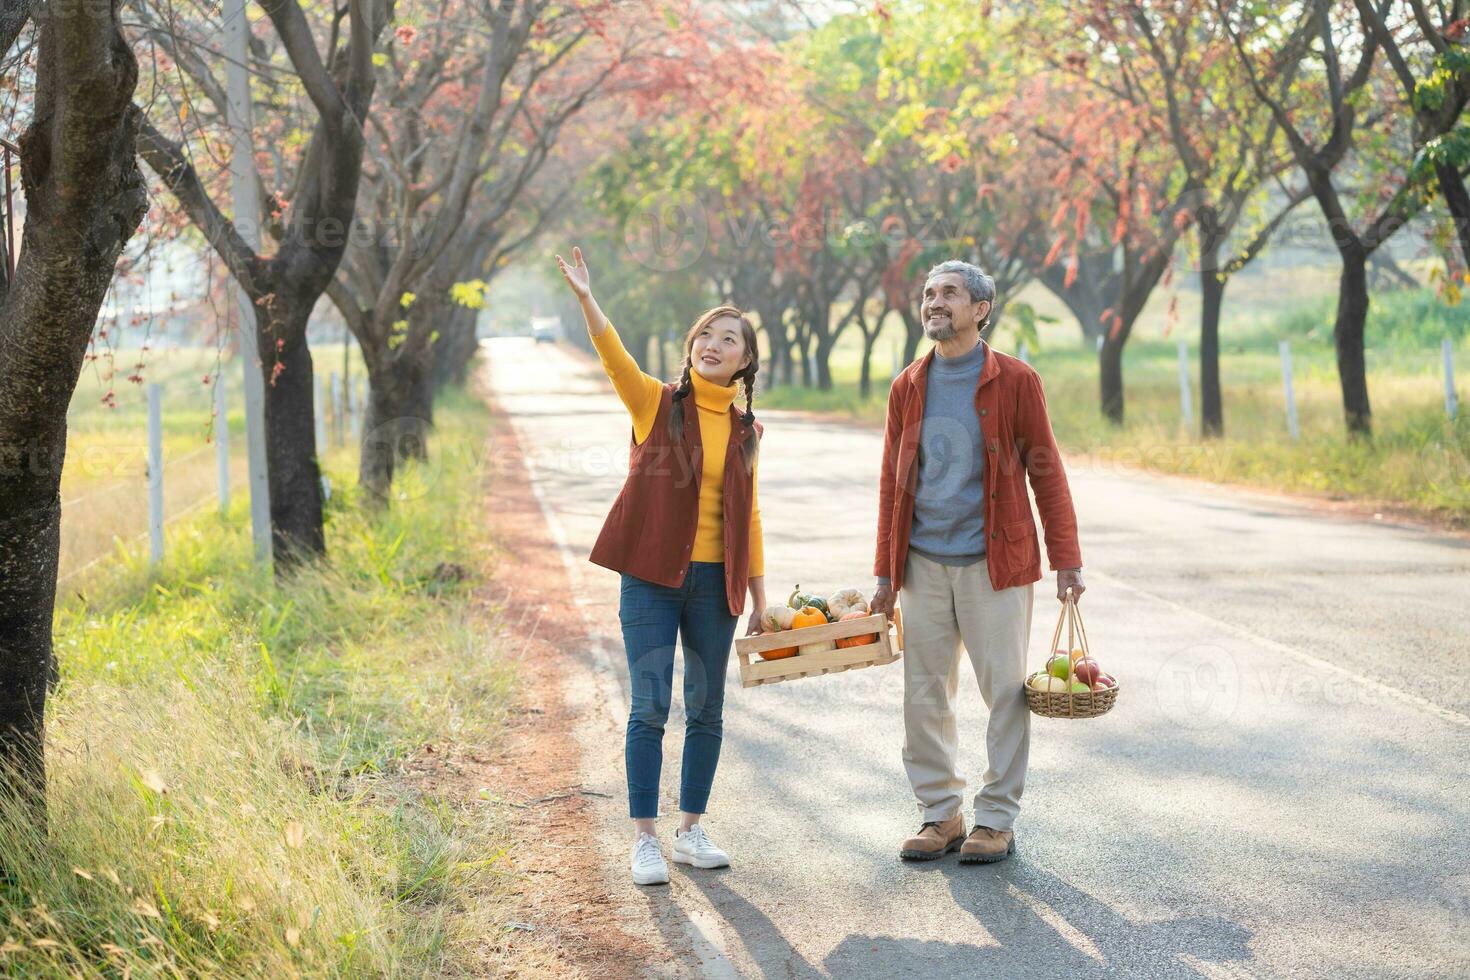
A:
0,379,546,977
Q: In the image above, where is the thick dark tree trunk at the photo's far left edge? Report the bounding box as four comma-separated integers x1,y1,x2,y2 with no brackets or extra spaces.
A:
0,1,148,811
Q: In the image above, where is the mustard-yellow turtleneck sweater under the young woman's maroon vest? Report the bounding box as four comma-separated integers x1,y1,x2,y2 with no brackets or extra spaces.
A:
592,322,766,579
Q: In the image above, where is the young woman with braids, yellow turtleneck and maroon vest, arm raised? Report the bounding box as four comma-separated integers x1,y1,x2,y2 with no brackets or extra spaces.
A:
556,248,766,884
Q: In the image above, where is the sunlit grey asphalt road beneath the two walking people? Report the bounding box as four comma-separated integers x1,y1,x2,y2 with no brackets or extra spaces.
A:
488,339,1470,979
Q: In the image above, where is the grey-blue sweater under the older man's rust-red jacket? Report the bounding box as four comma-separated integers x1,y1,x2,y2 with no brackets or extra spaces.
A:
879,344,985,583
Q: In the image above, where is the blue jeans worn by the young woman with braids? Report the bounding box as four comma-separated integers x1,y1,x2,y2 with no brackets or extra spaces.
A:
617,561,739,820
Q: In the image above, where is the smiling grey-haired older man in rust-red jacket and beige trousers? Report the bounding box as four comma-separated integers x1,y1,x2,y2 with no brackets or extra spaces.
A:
872,260,1083,862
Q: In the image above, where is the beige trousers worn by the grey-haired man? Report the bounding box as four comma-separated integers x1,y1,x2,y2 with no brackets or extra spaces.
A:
900,551,1033,830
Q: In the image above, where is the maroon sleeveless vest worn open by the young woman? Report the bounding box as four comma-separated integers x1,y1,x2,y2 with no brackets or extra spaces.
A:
589,383,761,616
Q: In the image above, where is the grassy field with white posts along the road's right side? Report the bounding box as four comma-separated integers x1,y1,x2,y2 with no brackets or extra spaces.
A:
759,270,1470,527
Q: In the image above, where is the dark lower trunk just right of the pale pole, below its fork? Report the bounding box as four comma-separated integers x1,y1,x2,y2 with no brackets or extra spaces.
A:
256,307,326,573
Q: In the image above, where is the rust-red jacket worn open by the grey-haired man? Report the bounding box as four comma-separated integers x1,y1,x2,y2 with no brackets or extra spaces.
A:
873,341,1082,591
